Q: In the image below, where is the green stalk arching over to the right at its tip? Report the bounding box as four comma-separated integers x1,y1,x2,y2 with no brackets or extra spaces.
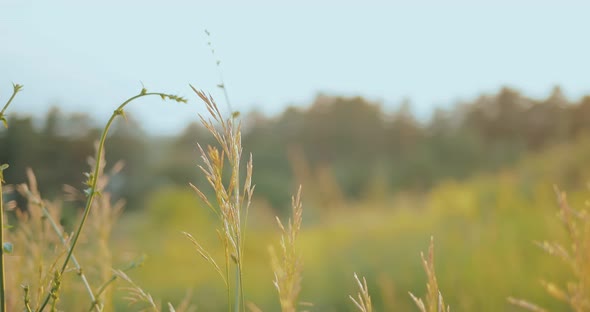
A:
38,88,186,311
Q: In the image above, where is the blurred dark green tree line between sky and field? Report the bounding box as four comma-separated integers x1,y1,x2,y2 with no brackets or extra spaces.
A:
0,87,590,212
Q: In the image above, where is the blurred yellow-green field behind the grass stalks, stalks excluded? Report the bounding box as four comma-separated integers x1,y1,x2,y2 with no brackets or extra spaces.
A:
105,140,590,311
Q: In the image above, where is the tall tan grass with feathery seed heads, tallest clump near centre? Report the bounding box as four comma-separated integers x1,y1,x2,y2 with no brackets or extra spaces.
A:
191,86,254,311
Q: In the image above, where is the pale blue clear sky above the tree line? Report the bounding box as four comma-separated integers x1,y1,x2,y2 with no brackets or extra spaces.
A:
0,0,590,133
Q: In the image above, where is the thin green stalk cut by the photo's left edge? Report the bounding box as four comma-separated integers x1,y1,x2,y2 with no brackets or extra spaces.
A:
0,83,23,312
